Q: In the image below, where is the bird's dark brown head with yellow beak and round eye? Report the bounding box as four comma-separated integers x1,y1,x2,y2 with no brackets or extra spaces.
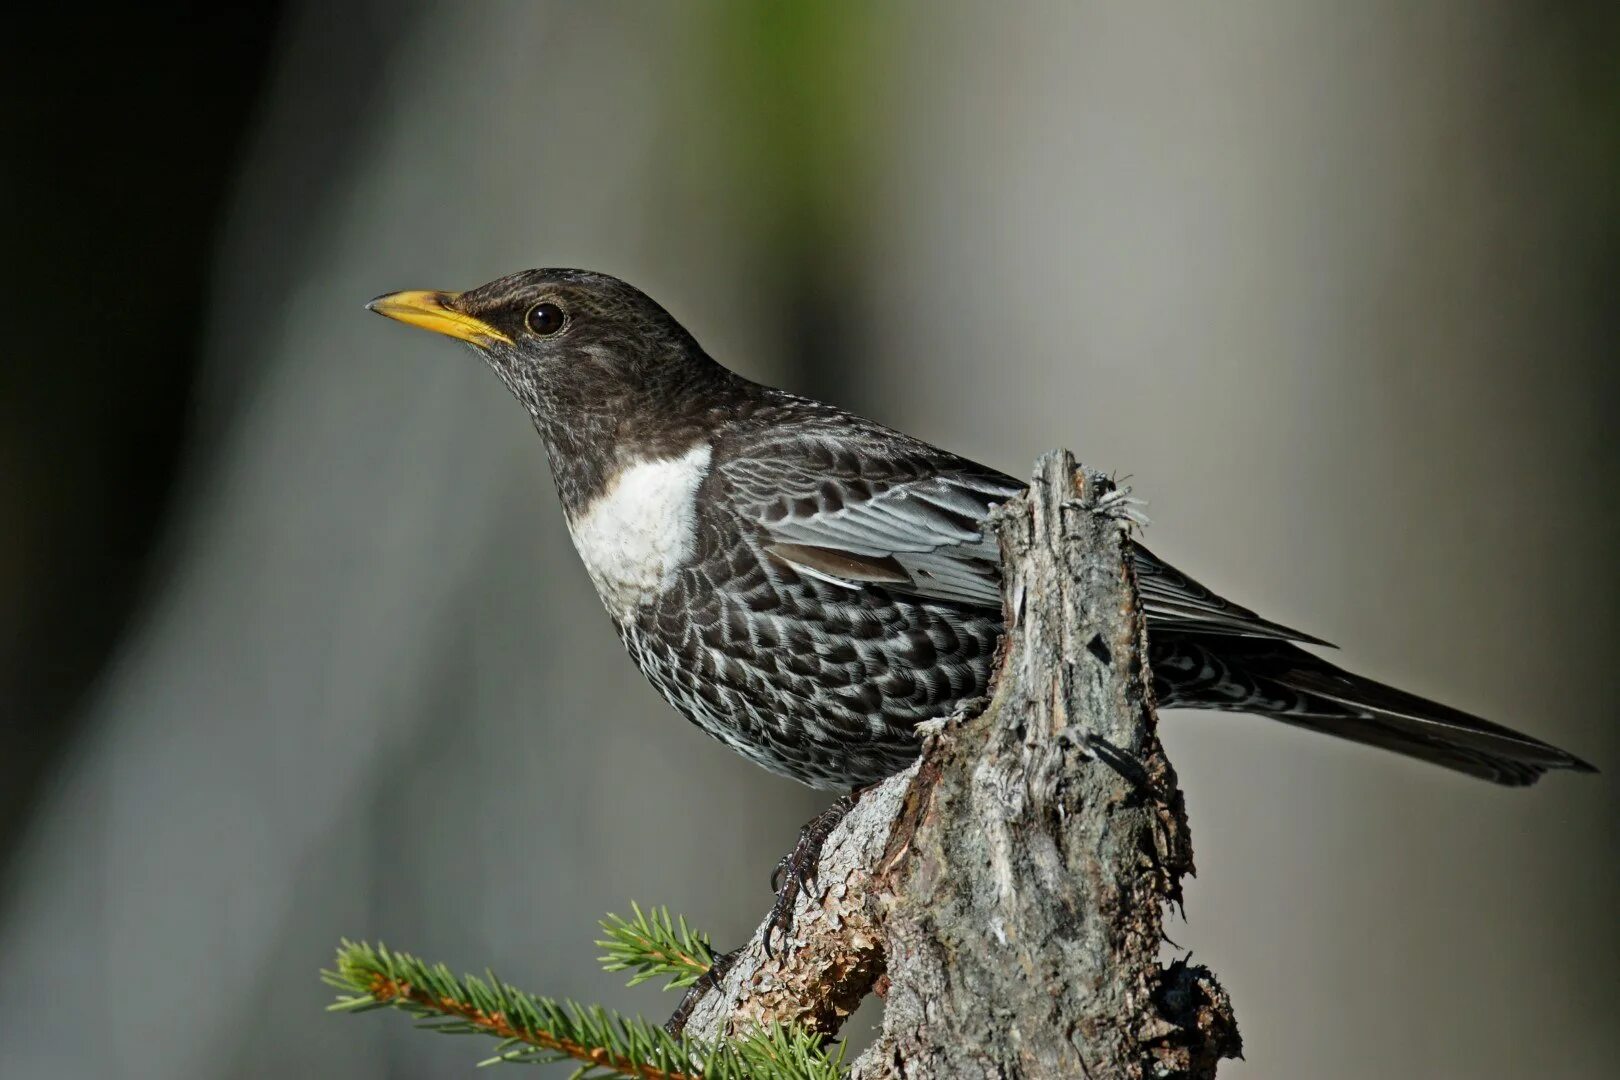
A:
366,269,714,419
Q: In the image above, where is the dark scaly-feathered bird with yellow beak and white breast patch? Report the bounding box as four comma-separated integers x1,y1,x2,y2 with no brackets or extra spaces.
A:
369,270,1591,790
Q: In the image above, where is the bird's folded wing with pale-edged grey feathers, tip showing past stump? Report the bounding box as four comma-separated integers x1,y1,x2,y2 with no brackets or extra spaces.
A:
718,404,1327,644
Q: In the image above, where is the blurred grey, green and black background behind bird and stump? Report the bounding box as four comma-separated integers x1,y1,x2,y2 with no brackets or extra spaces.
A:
0,0,1620,1080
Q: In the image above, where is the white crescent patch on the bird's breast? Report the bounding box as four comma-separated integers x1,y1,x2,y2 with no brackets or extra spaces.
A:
569,444,710,619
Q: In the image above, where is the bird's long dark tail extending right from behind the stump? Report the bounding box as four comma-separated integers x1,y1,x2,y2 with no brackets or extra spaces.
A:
1150,631,1596,787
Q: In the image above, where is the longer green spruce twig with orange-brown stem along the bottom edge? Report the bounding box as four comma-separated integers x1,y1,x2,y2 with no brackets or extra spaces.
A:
321,916,842,1080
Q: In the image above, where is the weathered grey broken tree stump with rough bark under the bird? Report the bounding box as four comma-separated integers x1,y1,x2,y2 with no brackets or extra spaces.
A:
670,452,1241,1080
